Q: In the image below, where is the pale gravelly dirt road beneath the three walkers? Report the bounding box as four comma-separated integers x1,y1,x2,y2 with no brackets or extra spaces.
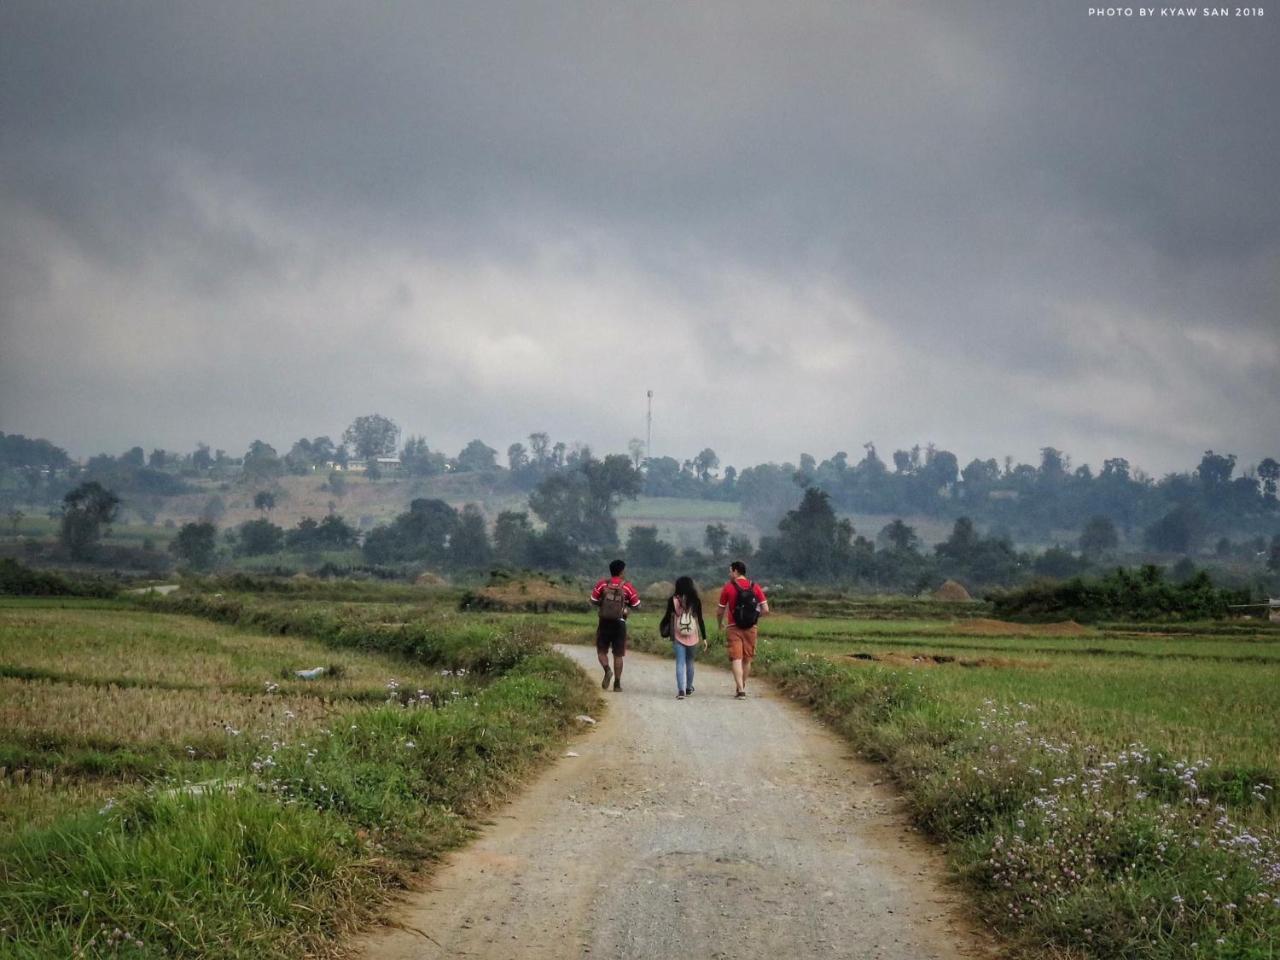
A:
358,646,992,960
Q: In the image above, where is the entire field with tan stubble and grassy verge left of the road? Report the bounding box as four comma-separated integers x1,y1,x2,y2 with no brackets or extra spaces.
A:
0,596,596,957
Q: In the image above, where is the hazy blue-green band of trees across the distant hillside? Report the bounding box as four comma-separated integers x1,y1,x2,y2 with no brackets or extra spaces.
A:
0,424,1280,599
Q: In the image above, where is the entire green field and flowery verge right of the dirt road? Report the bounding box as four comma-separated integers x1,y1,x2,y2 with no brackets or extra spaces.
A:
721,617,1280,960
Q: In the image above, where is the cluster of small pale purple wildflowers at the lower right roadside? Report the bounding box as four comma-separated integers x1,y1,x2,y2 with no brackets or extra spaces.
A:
962,703,1280,956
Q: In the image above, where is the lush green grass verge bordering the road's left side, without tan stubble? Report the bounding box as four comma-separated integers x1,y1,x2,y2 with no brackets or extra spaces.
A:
0,598,598,957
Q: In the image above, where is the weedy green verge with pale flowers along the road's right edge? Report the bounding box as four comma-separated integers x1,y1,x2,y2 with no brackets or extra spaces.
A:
756,648,1280,960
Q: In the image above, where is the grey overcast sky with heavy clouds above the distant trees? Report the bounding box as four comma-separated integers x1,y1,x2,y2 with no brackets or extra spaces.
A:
0,0,1280,475
